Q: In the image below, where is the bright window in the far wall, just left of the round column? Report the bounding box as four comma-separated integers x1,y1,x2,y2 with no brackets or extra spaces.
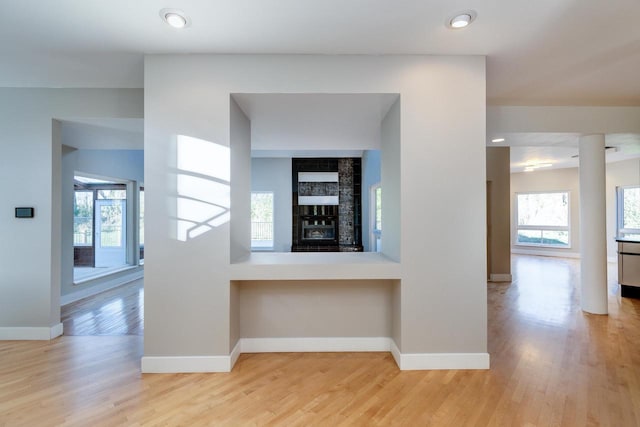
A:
516,191,570,248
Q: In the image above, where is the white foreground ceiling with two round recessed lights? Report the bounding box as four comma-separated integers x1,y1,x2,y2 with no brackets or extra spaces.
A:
0,0,640,105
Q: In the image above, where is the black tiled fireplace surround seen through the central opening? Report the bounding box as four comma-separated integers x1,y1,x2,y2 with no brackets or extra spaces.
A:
291,157,363,252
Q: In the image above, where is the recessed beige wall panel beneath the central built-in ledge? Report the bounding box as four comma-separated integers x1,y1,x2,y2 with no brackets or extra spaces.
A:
239,280,391,338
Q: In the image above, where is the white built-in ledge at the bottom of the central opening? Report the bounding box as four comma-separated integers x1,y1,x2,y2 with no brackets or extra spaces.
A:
230,252,401,280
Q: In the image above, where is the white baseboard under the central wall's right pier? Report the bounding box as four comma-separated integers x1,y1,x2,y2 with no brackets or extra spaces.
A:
399,353,489,371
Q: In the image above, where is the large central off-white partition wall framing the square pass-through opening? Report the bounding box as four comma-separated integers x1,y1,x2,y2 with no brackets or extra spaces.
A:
145,55,487,362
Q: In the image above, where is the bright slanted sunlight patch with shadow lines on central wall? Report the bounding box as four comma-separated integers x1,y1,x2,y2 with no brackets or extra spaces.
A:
174,135,231,242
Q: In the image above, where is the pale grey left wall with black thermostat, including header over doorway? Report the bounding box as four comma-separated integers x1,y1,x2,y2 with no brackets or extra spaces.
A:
0,88,143,335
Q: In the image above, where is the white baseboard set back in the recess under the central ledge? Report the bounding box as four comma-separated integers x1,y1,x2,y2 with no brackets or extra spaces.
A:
240,337,391,353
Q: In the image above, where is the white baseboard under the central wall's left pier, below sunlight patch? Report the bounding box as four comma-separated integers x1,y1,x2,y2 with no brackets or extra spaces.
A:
141,356,231,374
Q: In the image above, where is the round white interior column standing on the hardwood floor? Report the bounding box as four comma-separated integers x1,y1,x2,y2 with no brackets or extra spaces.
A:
579,134,608,314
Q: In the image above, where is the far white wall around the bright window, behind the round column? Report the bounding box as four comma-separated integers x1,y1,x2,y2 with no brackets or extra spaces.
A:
511,159,640,260
